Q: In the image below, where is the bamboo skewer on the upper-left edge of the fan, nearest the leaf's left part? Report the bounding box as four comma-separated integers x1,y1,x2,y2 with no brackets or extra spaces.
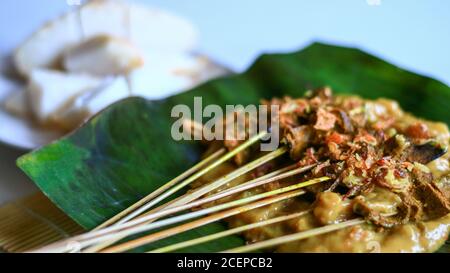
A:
93,148,226,230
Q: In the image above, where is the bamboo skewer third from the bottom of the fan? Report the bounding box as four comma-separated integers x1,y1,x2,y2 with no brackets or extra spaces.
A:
101,190,305,253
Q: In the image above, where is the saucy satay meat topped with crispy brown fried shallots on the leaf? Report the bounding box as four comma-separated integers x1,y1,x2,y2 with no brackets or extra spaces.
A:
195,88,450,252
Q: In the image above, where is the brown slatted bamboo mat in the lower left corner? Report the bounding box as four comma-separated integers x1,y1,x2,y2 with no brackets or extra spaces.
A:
0,193,83,252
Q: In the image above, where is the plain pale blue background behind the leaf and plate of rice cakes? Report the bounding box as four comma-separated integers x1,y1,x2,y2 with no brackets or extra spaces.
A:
0,0,450,84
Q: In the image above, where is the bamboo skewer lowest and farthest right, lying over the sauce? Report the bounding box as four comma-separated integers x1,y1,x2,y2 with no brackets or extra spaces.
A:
221,218,365,253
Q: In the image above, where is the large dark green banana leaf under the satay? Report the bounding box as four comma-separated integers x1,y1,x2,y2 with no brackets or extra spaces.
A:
18,43,450,252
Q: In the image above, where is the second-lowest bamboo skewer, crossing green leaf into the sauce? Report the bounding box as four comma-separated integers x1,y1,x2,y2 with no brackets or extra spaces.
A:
148,210,311,253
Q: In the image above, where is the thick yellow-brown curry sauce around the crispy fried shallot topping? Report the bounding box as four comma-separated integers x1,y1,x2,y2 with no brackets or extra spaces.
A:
194,92,450,252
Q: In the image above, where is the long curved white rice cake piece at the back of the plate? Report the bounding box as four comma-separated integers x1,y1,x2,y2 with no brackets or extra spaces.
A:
14,0,197,76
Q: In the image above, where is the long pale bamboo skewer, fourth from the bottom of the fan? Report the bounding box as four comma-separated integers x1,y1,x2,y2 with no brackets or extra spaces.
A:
30,177,329,252
